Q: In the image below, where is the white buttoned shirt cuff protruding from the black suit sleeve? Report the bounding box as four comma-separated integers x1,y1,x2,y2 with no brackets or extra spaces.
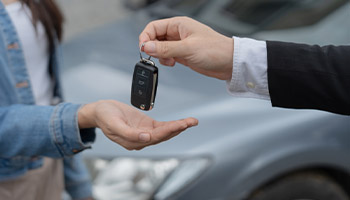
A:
226,37,270,100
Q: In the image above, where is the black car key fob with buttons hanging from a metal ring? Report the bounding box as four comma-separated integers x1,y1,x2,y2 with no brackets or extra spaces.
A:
131,44,158,111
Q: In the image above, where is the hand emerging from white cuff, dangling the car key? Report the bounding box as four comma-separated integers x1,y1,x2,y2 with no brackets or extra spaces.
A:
139,17,233,80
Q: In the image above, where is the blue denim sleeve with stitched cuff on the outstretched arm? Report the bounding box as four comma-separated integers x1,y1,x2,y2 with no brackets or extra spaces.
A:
0,103,95,158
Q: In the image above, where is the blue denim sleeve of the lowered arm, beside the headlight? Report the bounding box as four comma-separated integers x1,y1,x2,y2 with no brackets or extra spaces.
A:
63,154,92,199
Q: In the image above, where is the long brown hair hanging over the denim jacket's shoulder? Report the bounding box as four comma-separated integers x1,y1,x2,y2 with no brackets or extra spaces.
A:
20,0,64,51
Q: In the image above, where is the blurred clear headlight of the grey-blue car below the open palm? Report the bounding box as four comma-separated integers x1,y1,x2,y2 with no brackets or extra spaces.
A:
88,158,209,200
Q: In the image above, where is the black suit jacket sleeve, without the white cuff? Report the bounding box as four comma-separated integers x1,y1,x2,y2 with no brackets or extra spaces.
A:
267,41,350,115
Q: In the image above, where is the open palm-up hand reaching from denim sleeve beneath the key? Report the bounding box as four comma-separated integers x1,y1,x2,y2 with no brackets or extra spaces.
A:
78,100,198,150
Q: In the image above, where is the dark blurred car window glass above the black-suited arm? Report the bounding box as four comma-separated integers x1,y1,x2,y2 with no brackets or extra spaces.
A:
223,0,348,30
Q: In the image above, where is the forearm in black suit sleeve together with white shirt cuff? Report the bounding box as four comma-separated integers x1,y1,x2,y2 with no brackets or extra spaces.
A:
227,38,350,115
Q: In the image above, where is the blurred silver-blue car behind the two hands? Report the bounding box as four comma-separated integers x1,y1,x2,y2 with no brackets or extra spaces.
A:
62,0,350,200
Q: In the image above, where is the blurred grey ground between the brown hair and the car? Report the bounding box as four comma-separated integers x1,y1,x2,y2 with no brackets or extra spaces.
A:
57,0,132,41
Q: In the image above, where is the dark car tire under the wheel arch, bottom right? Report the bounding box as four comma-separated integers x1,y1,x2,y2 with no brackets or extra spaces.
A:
248,172,349,200
